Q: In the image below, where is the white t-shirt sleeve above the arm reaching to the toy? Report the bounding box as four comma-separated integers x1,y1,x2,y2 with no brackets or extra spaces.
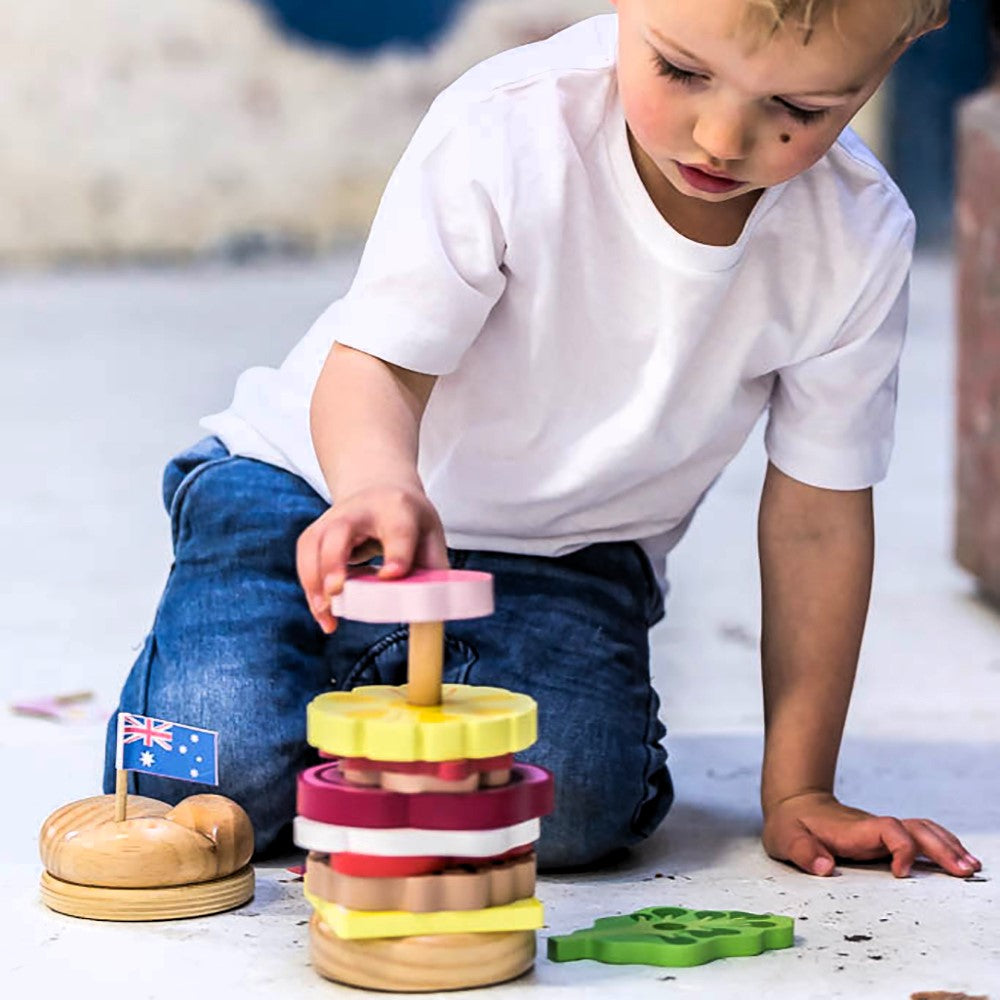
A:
316,92,505,375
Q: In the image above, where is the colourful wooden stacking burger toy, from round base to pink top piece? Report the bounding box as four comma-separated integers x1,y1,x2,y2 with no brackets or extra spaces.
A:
295,570,553,992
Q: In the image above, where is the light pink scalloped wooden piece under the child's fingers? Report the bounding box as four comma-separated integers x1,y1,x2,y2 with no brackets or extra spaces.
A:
330,567,493,622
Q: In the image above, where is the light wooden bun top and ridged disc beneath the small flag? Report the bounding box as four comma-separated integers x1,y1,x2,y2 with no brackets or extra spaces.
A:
39,788,254,920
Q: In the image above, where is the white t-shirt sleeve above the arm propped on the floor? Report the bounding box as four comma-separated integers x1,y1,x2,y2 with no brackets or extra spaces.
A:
764,212,914,490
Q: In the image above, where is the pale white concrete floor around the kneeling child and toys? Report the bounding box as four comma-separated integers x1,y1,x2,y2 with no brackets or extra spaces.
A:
0,253,1000,1000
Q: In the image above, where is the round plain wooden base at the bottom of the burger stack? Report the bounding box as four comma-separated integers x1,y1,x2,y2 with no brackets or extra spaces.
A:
309,913,535,993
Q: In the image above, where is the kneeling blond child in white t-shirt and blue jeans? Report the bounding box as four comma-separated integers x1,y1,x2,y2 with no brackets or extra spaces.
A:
106,0,979,876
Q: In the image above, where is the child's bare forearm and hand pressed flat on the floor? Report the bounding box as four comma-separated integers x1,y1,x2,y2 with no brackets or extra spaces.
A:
759,466,980,876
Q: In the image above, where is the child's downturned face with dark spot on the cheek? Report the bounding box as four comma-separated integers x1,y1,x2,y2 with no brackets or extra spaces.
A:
612,0,905,202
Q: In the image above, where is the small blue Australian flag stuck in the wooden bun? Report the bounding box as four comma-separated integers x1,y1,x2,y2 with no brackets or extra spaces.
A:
117,712,219,785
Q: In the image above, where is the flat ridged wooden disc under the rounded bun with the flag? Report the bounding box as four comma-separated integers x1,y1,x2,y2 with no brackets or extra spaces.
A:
42,865,254,920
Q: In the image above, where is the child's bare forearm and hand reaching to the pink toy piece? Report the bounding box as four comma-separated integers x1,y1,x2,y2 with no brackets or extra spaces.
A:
297,344,448,632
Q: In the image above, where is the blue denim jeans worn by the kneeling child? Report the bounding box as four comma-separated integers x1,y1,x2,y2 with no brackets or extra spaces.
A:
104,438,673,869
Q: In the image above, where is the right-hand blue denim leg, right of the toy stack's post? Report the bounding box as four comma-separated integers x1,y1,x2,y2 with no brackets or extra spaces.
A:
449,544,673,869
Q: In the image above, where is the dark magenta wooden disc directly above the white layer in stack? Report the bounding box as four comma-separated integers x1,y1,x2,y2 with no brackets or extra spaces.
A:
298,764,555,830
